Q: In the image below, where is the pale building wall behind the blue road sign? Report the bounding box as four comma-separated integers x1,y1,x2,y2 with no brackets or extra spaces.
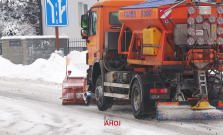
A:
41,0,98,39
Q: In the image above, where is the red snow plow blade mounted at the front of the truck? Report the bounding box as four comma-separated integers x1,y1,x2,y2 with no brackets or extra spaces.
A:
62,77,91,105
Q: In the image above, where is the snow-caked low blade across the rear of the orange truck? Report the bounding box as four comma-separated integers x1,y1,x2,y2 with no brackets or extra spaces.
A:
157,101,223,121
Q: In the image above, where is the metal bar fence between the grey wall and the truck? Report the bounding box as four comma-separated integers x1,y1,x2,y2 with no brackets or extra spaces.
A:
68,38,87,53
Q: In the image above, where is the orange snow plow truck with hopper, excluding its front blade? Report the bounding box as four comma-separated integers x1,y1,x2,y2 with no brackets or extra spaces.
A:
61,0,223,120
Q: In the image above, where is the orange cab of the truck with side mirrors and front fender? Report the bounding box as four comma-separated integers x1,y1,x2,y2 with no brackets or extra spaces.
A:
81,0,145,93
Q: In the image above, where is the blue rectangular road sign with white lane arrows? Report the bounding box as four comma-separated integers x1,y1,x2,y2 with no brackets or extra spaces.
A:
45,0,68,27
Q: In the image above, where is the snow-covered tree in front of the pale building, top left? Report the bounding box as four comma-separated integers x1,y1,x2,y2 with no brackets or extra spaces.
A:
0,0,40,36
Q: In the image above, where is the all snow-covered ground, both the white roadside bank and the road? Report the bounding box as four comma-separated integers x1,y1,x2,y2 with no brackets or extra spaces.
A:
0,52,223,135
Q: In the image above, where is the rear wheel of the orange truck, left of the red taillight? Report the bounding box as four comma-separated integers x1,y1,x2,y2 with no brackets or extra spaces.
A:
131,81,144,119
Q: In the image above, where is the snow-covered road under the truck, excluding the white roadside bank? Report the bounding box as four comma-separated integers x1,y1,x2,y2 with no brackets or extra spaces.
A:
0,78,223,135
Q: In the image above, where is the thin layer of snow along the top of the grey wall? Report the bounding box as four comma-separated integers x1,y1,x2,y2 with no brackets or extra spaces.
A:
1,35,69,40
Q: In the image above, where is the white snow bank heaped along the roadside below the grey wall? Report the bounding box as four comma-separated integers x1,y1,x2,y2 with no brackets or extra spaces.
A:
0,51,88,83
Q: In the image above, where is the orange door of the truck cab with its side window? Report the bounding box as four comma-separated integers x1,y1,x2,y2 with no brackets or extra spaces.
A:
87,8,98,65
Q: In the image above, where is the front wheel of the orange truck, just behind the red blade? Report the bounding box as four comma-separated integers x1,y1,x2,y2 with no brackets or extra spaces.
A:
95,75,113,111
